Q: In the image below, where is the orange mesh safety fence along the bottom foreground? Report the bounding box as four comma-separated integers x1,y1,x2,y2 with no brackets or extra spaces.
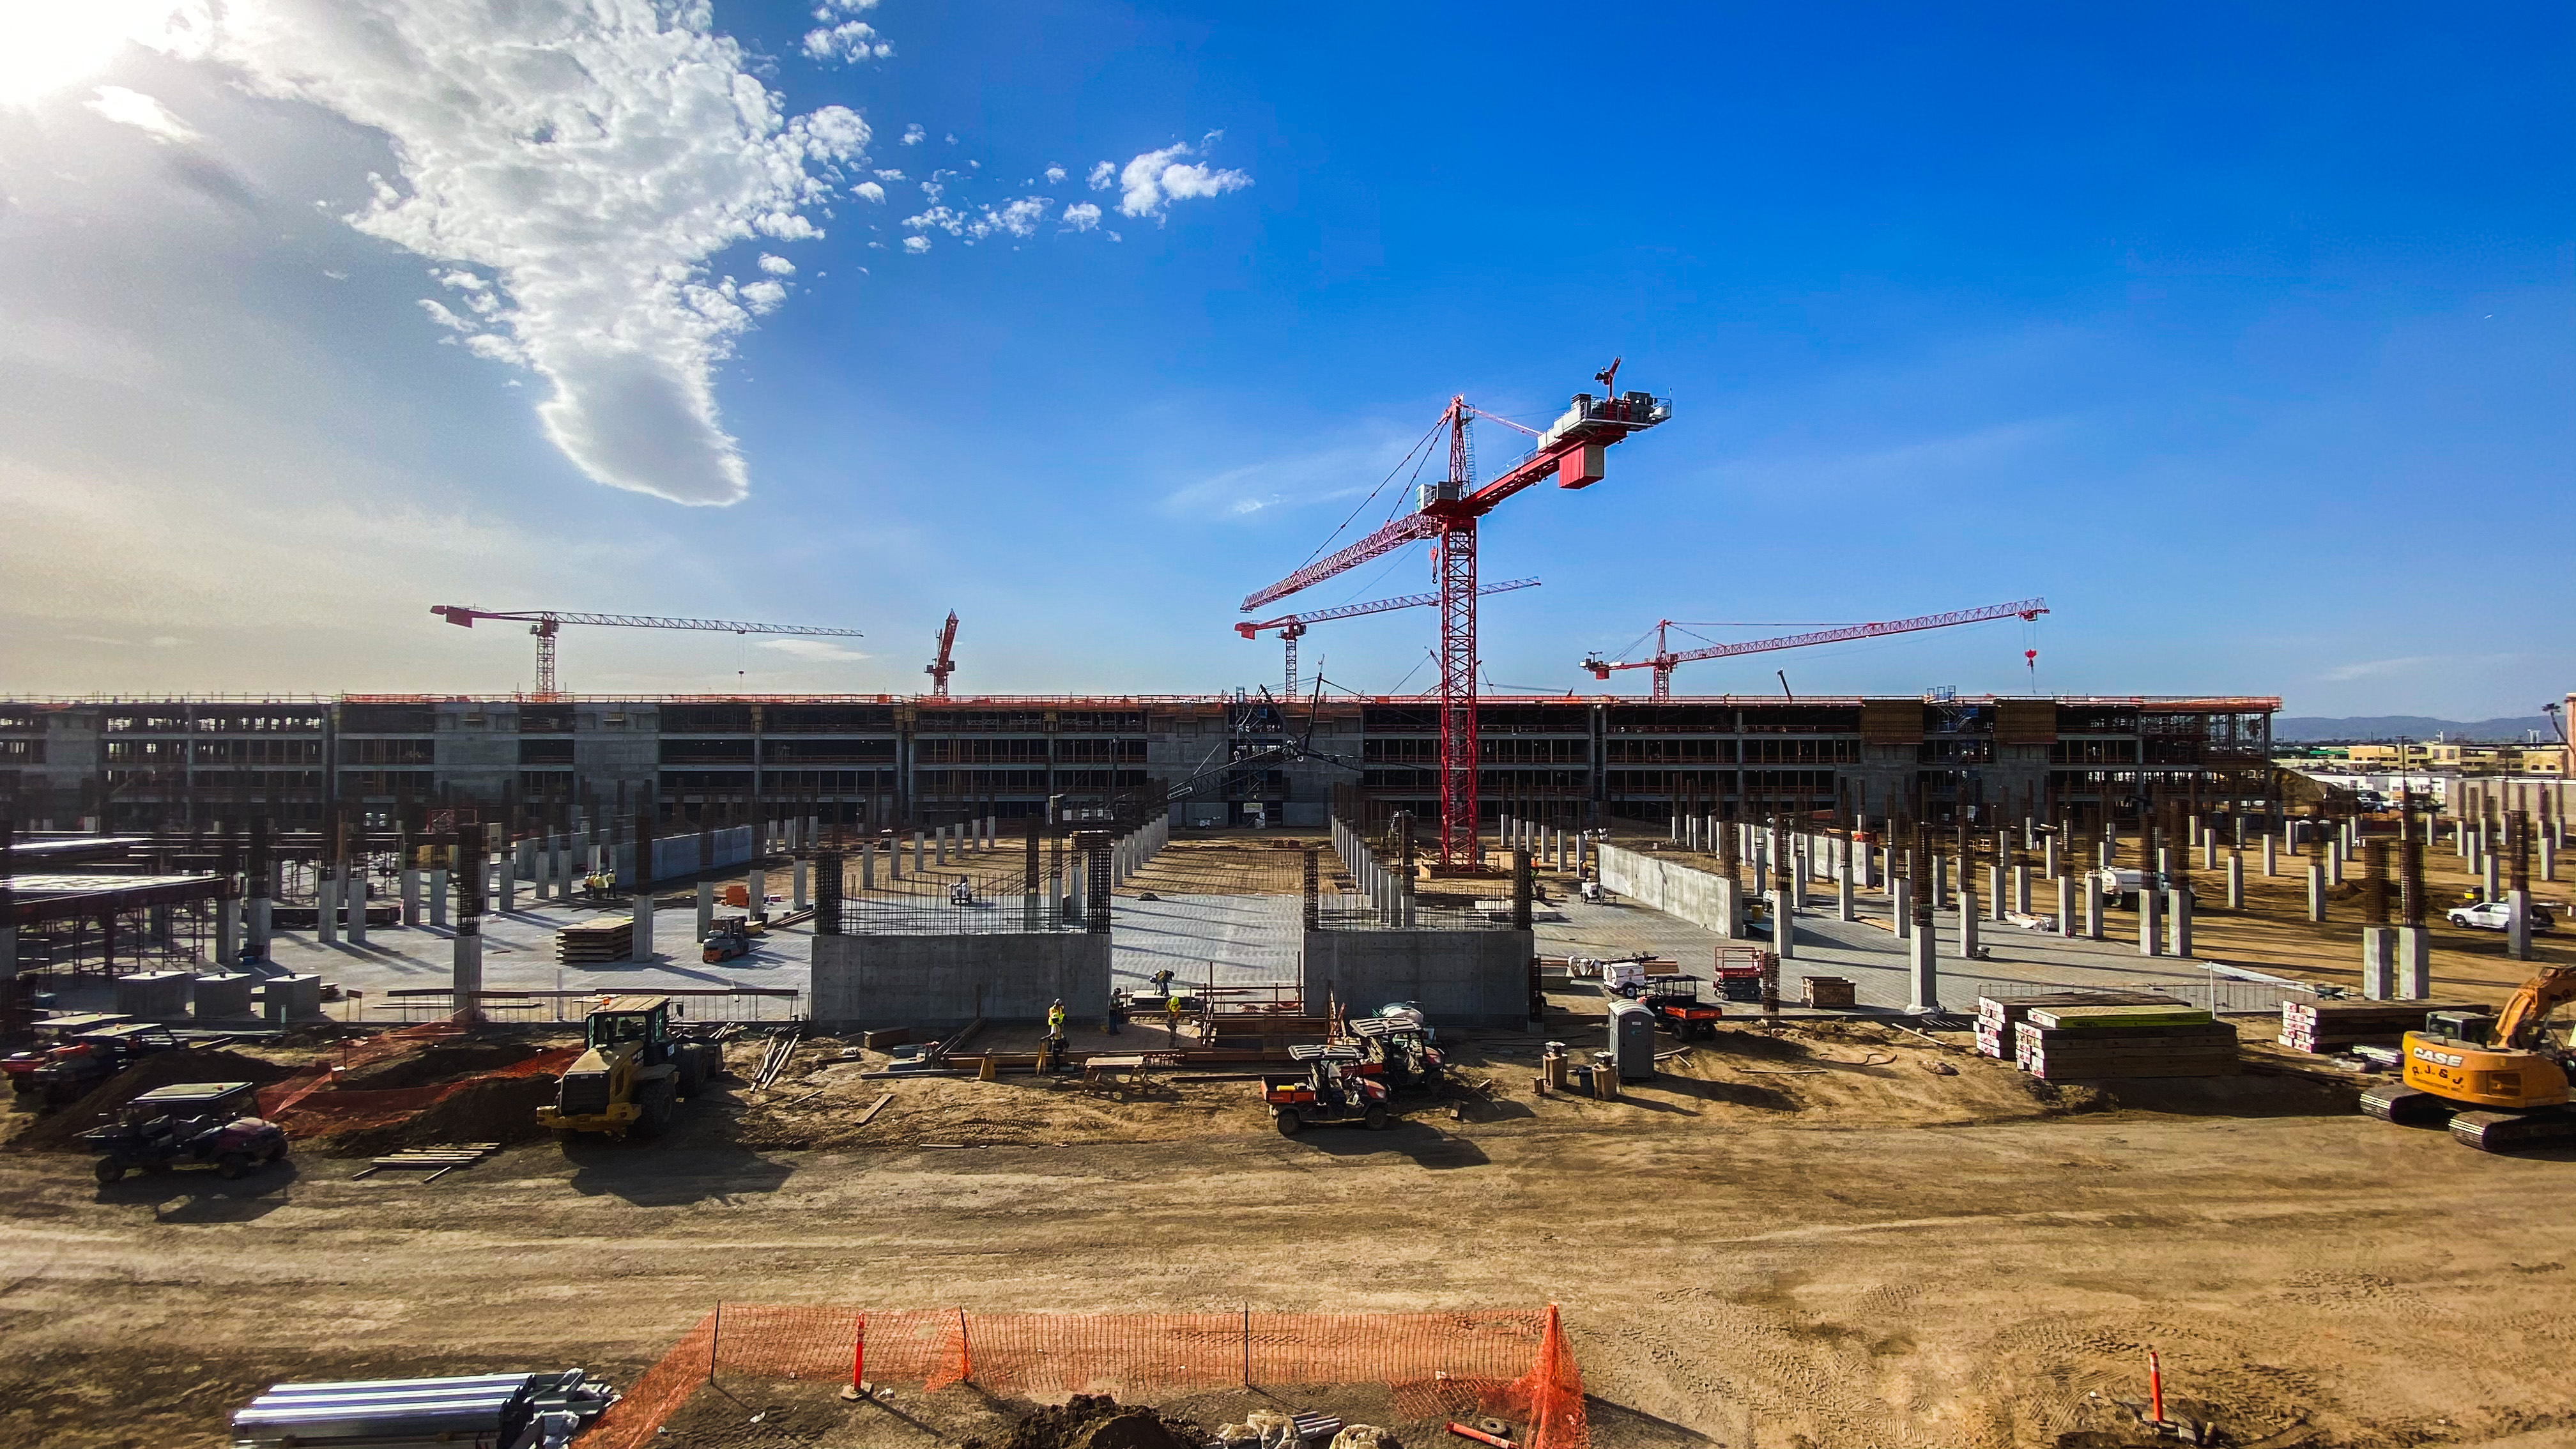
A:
579,1302,1590,1449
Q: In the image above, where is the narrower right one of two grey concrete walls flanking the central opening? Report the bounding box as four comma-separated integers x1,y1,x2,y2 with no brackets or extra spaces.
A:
1303,931,1535,1026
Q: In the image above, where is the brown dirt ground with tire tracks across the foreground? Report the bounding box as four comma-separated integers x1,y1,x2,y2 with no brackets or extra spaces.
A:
0,1000,2576,1449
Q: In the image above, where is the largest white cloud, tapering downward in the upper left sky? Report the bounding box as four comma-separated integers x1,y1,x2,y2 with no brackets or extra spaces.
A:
129,0,868,505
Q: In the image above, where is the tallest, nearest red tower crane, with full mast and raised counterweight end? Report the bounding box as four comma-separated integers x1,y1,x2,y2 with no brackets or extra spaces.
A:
1244,361,1672,869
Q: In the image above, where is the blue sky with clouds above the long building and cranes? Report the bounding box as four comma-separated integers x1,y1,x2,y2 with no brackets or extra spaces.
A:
0,0,2576,719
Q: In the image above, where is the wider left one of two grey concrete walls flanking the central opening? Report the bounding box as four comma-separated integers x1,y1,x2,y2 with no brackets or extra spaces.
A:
811,931,1110,1026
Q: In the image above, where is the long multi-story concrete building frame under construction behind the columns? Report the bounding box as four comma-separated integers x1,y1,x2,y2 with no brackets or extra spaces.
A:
0,694,2280,830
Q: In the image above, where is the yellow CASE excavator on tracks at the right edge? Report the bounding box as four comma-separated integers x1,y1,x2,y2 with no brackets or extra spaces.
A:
2362,967,2576,1153
